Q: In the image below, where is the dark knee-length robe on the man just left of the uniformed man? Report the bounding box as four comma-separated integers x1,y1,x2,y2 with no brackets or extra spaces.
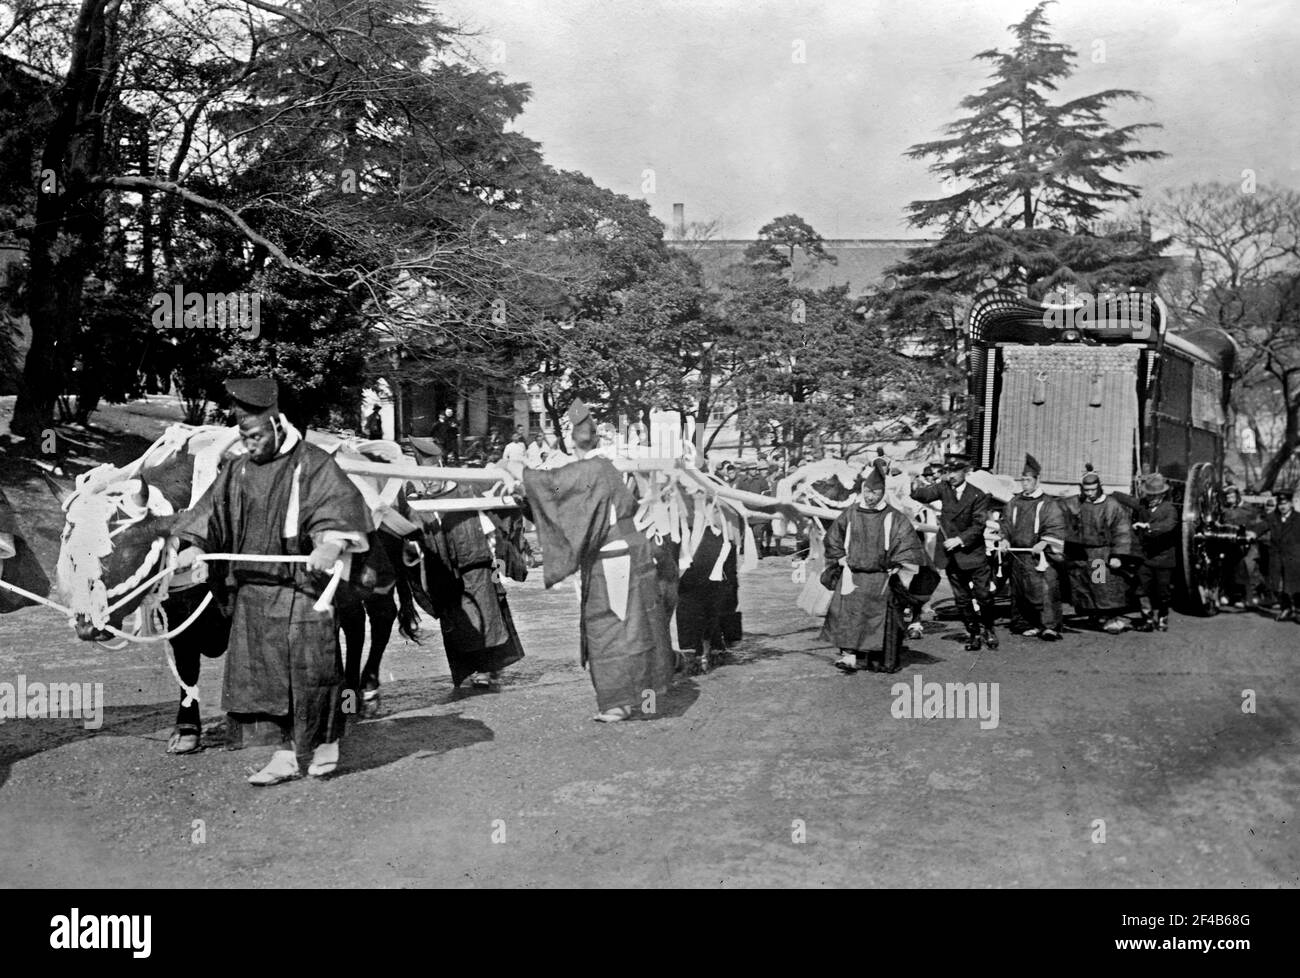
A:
822,503,937,668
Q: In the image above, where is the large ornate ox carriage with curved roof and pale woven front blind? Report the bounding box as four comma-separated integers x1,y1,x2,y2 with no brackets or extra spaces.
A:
966,291,1245,614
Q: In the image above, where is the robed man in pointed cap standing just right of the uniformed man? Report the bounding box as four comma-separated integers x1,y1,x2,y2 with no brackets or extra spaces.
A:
998,453,1067,641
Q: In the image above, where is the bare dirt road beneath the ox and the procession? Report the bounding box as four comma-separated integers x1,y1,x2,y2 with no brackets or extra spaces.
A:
0,559,1300,887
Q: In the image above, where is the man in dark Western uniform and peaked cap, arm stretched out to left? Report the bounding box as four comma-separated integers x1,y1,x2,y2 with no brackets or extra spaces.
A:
911,454,997,652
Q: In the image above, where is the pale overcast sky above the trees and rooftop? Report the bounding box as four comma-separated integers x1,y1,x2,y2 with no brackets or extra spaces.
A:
434,0,1300,238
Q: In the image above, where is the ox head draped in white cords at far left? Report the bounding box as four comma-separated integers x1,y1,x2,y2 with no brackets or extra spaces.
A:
59,471,176,641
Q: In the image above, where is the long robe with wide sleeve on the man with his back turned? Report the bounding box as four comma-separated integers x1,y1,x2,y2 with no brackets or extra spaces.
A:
524,458,677,713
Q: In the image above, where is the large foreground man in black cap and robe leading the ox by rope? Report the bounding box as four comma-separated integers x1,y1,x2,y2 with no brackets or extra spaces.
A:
173,377,373,786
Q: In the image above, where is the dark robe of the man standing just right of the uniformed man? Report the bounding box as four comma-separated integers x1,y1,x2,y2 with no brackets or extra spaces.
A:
1002,489,1069,632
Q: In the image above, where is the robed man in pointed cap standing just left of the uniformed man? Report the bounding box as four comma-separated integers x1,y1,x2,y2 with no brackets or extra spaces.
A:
822,464,939,672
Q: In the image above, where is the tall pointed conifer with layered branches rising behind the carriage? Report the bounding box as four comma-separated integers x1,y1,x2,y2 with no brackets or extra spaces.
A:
891,0,1166,317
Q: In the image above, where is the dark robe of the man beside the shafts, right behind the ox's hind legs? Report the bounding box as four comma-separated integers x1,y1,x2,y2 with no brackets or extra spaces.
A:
424,496,527,685
